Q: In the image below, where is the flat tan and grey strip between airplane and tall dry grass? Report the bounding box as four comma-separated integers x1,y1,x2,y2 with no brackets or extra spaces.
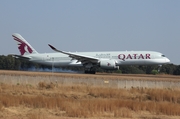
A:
0,70,180,89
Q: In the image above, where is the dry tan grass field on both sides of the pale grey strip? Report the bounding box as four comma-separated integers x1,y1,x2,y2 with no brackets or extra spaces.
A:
0,70,180,119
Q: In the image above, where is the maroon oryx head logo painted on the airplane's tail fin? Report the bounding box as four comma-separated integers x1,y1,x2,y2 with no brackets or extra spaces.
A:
13,35,33,55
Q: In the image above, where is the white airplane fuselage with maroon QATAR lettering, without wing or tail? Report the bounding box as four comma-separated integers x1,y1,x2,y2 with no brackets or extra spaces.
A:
26,51,170,66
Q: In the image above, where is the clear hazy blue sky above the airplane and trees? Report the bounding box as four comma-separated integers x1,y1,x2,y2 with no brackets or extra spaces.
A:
0,0,180,65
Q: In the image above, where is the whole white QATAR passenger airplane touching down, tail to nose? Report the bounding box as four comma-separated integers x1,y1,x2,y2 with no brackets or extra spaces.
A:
12,33,170,74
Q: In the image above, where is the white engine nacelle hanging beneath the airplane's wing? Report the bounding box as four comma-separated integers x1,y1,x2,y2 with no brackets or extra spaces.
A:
99,59,119,69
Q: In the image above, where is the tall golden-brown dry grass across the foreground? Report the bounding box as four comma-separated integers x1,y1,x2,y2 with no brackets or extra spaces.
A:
0,82,180,119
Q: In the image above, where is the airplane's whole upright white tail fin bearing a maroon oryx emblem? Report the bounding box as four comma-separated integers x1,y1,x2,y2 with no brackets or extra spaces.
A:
12,33,38,55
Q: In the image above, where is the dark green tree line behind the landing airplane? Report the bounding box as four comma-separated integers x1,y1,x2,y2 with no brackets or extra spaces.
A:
0,55,180,75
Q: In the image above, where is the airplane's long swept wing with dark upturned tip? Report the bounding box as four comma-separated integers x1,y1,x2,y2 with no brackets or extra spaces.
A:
48,44,99,63
